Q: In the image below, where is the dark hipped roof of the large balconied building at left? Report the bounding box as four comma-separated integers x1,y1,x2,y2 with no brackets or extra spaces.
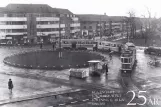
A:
0,4,73,14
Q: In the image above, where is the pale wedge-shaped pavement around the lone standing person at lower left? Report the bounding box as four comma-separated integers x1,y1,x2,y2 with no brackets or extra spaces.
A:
0,74,79,105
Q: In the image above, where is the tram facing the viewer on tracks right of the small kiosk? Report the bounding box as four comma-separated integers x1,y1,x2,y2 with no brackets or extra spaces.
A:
121,42,136,72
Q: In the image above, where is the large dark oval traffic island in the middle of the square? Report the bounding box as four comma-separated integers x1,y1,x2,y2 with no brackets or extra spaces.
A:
3,51,103,70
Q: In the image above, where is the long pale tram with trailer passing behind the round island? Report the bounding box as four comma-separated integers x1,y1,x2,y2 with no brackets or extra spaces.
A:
61,39,122,52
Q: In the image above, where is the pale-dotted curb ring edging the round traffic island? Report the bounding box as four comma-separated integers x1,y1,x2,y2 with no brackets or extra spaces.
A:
3,49,104,70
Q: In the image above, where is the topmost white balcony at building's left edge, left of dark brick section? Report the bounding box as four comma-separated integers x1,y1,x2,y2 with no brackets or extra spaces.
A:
0,17,27,22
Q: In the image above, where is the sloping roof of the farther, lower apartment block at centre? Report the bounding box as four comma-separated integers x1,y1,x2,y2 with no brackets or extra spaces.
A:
77,14,109,21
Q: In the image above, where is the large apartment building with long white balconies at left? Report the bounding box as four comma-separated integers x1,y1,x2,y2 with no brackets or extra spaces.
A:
0,4,80,44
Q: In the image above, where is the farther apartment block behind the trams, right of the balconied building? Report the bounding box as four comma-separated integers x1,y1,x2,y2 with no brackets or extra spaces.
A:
78,14,126,37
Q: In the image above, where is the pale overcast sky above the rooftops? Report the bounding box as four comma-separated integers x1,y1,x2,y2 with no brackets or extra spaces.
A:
0,0,161,17
